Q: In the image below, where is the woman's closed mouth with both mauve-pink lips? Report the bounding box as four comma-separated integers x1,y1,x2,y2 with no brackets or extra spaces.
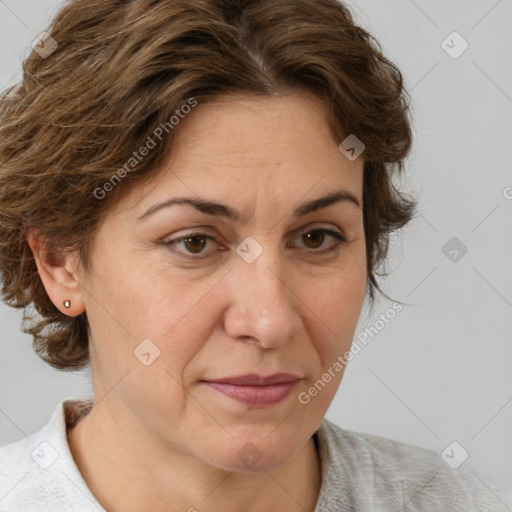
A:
202,373,302,407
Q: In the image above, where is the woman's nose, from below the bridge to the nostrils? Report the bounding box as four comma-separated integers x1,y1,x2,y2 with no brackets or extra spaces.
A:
224,251,302,348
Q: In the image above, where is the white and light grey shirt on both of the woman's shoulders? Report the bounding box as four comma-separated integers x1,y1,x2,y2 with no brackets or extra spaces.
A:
0,397,512,512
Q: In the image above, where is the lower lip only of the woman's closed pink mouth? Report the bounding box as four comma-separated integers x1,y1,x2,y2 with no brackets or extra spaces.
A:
206,380,299,406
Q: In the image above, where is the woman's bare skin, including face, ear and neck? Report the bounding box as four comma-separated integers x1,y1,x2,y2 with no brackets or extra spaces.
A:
29,91,367,512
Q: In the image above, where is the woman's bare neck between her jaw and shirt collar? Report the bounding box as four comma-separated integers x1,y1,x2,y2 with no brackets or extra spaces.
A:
68,400,321,512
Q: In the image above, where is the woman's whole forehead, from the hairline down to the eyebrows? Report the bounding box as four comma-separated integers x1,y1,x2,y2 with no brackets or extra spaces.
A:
120,92,363,213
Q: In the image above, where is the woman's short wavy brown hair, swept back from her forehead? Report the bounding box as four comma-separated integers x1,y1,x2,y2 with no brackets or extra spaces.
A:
0,0,417,370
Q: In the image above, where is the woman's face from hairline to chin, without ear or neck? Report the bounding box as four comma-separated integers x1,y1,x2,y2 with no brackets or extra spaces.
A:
74,93,367,471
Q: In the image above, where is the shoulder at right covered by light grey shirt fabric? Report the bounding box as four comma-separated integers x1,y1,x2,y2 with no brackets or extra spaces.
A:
318,420,512,512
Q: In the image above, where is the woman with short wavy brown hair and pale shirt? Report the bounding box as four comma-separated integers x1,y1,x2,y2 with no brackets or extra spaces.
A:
0,0,512,512
